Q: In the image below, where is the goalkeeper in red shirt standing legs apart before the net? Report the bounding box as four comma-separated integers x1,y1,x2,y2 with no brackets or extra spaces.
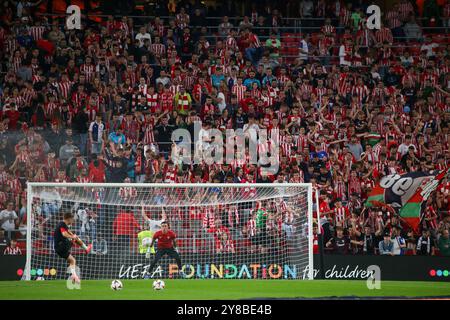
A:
148,221,185,277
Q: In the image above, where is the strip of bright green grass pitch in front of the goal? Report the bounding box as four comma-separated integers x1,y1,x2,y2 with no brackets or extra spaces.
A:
0,280,450,300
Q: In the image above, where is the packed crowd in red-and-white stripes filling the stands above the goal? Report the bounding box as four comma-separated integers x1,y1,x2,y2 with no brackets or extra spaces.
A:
0,0,450,255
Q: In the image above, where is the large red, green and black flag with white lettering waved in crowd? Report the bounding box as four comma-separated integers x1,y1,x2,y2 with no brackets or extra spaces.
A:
365,168,450,230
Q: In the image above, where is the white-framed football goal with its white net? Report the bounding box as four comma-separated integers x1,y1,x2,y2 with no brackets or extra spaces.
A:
24,183,313,280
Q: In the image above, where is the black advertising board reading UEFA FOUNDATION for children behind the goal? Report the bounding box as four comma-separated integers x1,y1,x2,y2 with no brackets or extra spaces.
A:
0,255,450,281
